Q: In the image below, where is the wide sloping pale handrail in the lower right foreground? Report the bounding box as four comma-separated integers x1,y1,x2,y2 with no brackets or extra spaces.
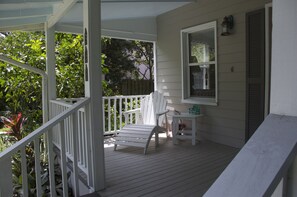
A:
204,114,297,197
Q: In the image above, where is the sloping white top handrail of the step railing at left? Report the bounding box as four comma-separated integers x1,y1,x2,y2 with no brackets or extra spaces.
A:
0,98,90,160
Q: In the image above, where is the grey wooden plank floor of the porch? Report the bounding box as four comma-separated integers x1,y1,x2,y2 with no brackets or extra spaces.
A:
99,135,239,197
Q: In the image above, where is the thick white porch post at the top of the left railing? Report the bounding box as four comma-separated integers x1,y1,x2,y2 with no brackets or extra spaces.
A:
83,0,105,191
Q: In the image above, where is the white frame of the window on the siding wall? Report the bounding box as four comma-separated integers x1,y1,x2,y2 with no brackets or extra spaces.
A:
180,21,218,106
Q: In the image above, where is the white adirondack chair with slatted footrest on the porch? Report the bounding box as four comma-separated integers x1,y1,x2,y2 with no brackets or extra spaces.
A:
114,91,168,154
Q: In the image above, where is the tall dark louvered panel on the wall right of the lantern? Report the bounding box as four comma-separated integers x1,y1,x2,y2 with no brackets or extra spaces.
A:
246,9,265,141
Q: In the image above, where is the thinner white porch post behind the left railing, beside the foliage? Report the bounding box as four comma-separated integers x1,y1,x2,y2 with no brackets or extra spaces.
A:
45,24,57,121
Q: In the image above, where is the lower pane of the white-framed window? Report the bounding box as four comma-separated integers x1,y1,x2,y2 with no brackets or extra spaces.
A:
190,64,216,98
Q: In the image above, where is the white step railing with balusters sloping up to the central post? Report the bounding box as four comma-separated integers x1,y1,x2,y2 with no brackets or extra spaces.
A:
0,98,92,197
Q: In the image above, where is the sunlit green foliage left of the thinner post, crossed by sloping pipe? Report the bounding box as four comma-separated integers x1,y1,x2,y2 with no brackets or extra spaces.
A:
0,32,45,132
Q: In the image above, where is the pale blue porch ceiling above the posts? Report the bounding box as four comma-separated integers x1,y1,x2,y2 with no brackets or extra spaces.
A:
0,0,194,41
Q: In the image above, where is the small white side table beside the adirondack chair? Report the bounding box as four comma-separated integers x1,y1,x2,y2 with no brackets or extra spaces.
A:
172,113,203,145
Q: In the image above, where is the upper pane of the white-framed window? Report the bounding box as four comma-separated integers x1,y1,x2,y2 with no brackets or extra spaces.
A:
189,28,215,63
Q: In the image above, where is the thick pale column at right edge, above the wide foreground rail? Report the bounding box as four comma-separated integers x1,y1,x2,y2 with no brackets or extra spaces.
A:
270,0,297,196
